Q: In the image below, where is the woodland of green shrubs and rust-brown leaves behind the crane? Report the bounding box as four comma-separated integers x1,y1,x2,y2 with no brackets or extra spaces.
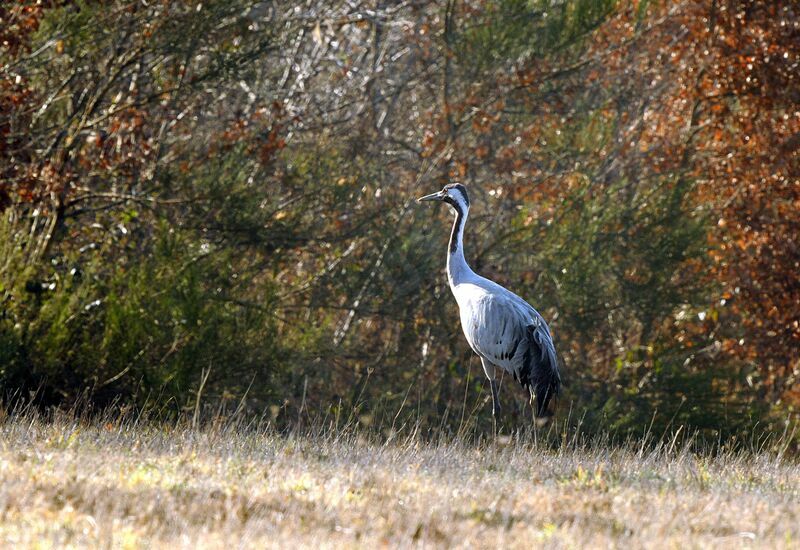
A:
0,0,800,438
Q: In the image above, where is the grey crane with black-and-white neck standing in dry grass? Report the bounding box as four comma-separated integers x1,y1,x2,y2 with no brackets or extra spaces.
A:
417,183,561,424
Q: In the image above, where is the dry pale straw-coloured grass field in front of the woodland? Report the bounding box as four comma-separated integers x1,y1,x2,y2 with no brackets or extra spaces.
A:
0,413,800,548
